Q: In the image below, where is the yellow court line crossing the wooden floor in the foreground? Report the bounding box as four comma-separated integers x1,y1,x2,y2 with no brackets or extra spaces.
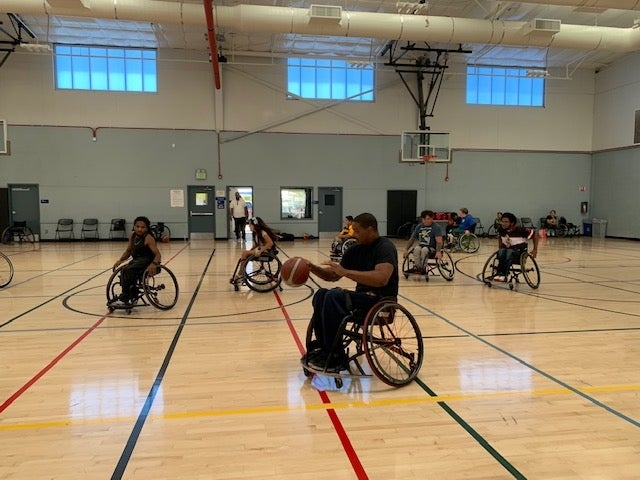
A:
0,385,640,431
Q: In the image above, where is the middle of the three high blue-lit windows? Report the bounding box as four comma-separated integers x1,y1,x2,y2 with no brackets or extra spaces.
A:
287,58,374,102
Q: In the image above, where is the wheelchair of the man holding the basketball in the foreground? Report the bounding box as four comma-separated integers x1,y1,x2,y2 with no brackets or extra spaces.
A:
300,290,424,388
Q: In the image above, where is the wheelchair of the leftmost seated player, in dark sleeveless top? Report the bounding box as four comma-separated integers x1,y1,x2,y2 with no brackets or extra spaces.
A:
107,265,179,313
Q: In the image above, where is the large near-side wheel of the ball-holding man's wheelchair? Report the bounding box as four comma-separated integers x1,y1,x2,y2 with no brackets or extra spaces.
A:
362,301,424,386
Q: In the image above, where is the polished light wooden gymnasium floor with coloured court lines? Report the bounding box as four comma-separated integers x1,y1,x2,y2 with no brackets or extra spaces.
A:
0,234,640,480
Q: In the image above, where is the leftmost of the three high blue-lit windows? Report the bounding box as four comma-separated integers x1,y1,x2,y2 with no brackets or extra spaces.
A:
54,45,158,92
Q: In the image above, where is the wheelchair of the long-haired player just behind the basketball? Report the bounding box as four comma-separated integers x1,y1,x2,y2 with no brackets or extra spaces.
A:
229,250,282,292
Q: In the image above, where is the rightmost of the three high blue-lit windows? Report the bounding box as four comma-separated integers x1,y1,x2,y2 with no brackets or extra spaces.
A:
467,66,545,107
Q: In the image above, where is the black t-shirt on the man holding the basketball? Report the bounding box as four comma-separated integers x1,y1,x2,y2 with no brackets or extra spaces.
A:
340,237,398,297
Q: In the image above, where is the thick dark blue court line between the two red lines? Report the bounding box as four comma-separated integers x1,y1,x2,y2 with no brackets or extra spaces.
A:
111,249,215,480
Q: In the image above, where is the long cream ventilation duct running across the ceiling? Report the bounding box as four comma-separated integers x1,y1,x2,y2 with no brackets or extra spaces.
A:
2,0,640,53
